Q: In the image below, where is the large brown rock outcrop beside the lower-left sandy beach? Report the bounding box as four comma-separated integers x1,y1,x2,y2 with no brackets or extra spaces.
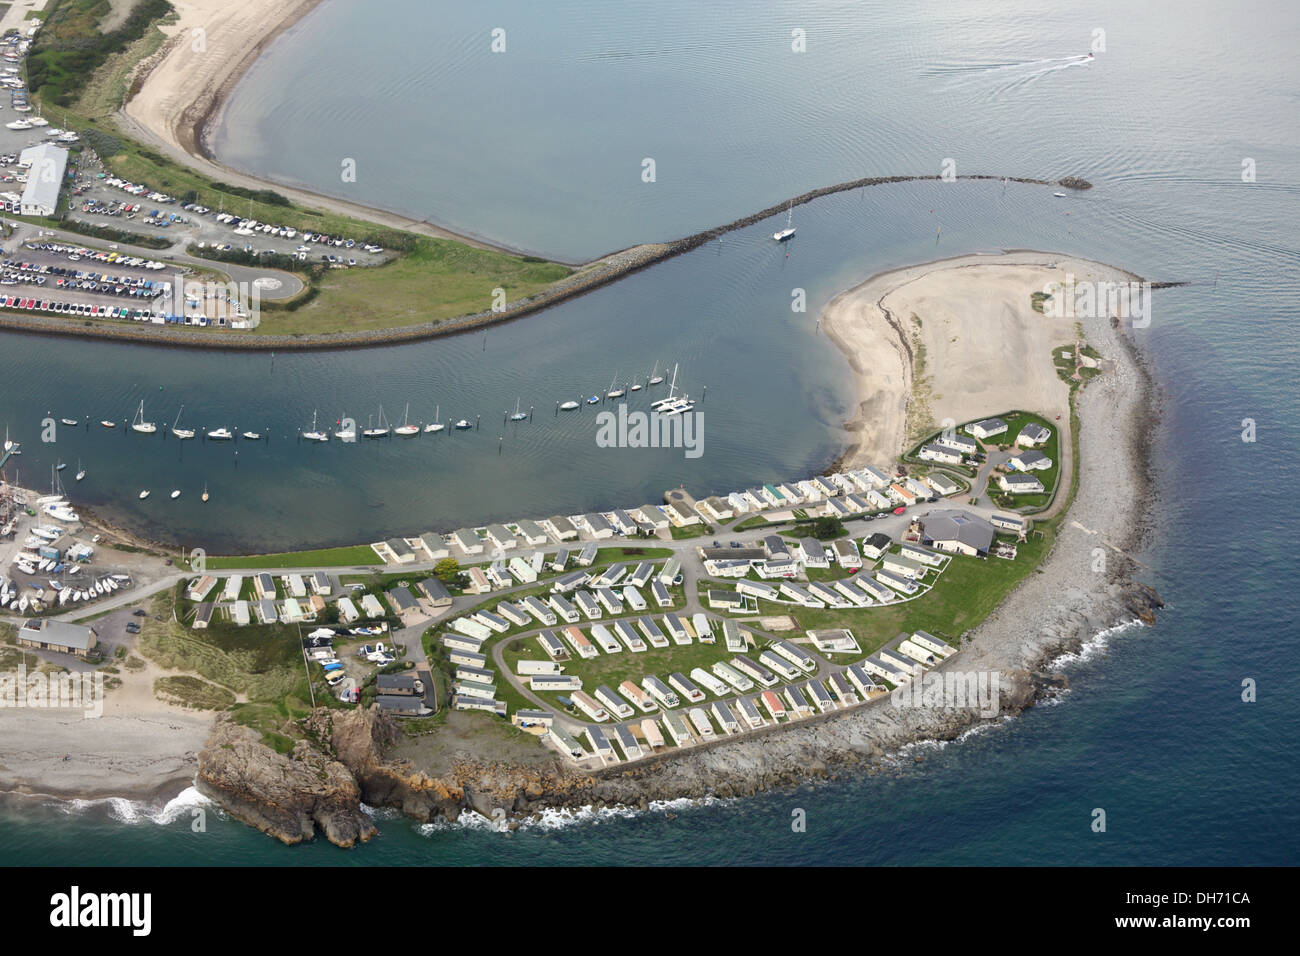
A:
195,718,376,847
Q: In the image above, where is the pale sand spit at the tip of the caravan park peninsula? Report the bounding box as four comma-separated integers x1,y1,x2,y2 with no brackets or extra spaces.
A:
822,252,1135,468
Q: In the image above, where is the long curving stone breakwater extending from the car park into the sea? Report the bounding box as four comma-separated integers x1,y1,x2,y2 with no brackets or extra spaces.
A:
0,176,1092,351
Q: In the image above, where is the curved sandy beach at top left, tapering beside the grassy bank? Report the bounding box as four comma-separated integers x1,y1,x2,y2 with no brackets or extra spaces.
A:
116,0,520,252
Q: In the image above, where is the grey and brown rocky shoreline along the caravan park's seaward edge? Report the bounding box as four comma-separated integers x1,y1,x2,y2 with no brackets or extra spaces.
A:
188,282,1162,847
